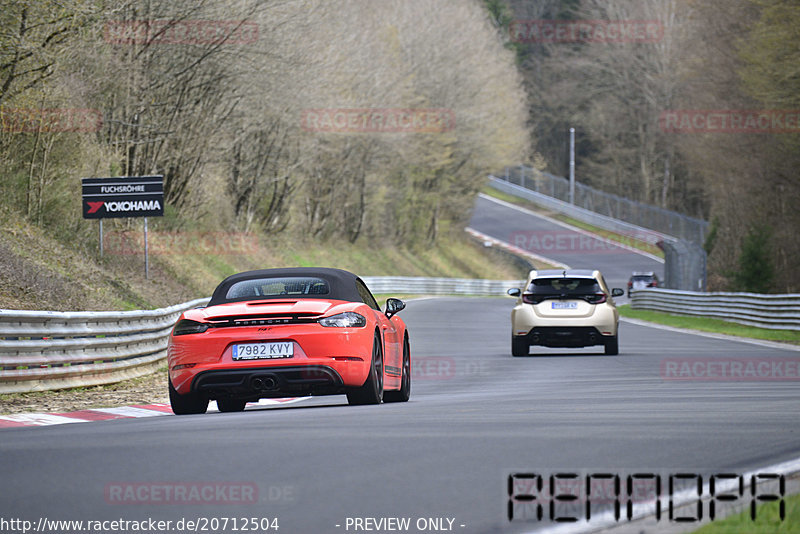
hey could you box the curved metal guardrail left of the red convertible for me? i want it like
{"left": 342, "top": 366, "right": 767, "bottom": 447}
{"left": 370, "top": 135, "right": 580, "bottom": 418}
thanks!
{"left": 0, "top": 298, "right": 208, "bottom": 393}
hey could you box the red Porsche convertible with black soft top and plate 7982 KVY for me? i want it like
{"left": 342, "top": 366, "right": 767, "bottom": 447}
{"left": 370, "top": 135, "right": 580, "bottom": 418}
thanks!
{"left": 167, "top": 268, "right": 411, "bottom": 414}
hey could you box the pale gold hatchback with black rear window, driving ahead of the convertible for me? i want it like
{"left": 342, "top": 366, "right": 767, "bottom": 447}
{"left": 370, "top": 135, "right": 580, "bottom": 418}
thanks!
{"left": 508, "top": 269, "right": 625, "bottom": 356}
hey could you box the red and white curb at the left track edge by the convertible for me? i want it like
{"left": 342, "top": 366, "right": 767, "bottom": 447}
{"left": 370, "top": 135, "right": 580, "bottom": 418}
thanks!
{"left": 0, "top": 397, "right": 309, "bottom": 428}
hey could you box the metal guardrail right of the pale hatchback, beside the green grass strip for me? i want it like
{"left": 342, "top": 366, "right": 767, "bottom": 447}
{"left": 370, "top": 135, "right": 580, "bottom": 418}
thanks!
{"left": 631, "top": 289, "right": 800, "bottom": 330}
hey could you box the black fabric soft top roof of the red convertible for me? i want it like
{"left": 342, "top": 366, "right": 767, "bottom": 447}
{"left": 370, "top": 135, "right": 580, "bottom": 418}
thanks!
{"left": 208, "top": 267, "right": 363, "bottom": 306}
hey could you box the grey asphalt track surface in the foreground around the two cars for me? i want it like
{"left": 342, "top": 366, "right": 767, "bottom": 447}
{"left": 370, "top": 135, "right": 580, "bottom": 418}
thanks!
{"left": 0, "top": 297, "right": 800, "bottom": 533}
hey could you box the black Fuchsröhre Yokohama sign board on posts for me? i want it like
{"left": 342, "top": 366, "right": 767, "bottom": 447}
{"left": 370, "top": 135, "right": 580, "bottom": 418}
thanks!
{"left": 81, "top": 176, "right": 164, "bottom": 219}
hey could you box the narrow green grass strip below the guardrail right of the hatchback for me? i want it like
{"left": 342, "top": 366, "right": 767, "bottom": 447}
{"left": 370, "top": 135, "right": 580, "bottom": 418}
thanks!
{"left": 617, "top": 304, "right": 800, "bottom": 344}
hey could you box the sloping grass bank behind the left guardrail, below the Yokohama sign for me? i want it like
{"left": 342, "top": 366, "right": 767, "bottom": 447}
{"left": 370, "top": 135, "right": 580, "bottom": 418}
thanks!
{"left": 0, "top": 209, "right": 527, "bottom": 311}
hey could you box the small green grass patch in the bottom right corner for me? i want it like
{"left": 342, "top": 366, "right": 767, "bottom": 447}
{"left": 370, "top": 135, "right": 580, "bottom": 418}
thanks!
{"left": 695, "top": 495, "right": 800, "bottom": 534}
